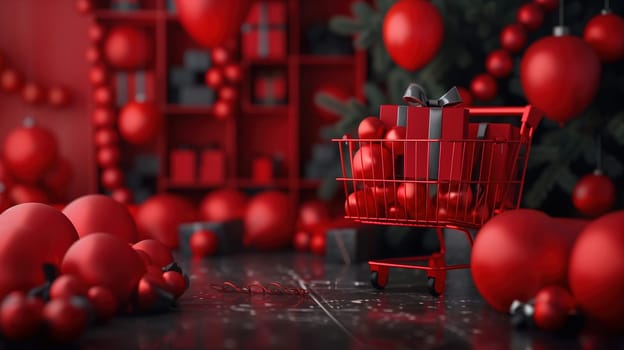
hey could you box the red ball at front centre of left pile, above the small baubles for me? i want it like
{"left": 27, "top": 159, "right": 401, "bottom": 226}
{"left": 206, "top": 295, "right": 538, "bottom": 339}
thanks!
{"left": 61, "top": 234, "right": 145, "bottom": 304}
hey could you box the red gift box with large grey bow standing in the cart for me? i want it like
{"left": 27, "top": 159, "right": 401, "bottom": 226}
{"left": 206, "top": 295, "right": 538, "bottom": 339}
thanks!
{"left": 379, "top": 84, "right": 471, "bottom": 182}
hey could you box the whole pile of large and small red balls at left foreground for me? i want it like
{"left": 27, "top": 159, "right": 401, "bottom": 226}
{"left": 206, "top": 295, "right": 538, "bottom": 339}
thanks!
{"left": 0, "top": 195, "right": 189, "bottom": 342}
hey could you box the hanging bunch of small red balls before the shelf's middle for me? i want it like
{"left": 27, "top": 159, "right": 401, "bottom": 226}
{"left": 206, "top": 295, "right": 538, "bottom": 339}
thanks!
{"left": 204, "top": 47, "right": 243, "bottom": 120}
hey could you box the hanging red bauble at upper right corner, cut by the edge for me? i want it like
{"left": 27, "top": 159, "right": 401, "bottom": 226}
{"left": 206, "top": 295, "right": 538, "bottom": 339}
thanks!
{"left": 583, "top": 13, "right": 624, "bottom": 62}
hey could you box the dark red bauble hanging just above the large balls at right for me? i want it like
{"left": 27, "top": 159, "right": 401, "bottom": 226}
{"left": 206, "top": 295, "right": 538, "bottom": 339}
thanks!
{"left": 572, "top": 174, "right": 616, "bottom": 216}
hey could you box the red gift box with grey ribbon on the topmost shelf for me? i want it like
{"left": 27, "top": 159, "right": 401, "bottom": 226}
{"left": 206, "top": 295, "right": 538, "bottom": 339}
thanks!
{"left": 242, "top": 1, "right": 286, "bottom": 58}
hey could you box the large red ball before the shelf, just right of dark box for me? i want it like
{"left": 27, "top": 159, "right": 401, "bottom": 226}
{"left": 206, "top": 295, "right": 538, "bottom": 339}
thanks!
{"left": 244, "top": 191, "right": 295, "bottom": 250}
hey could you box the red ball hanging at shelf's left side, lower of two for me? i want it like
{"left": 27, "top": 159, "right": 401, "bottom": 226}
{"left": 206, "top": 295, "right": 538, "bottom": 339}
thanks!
{"left": 118, "top": 101, "right": 163, "bottom": 145}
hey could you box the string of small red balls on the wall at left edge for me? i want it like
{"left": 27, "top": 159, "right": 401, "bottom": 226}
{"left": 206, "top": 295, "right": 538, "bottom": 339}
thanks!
{"left": 0, "top": 53, "right": 71, "bottom": 108}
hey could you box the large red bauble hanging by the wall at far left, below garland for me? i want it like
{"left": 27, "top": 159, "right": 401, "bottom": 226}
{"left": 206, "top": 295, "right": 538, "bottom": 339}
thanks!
{"left": 2, "top": 125, "right": 58, "bottom": 183}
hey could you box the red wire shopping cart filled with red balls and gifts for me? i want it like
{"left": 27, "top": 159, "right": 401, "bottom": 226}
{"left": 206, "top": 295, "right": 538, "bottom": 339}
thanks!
{"left": 333, "top": 105, "right": 542, "bottom": 296}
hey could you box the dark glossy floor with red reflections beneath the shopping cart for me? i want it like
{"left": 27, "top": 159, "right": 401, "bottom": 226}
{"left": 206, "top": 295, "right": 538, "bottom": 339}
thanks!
{"left": 64, "top": 253, "right": 624, "bottom": 350}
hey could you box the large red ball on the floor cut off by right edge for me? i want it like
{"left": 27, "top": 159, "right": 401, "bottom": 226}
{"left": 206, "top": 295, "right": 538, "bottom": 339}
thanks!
{"left": 570, "top": 211, "right": 624, "bottom": 330}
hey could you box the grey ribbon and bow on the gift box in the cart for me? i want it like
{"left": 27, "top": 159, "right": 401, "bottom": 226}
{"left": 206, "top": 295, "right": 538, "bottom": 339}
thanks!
{"left": 397, "top": 83, "right": 462, "bottom": 179}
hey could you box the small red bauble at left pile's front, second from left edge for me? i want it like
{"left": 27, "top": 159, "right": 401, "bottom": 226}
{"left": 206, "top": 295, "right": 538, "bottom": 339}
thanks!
{"left": 43, "top": 299, "right": 88, "bottom": 343}
